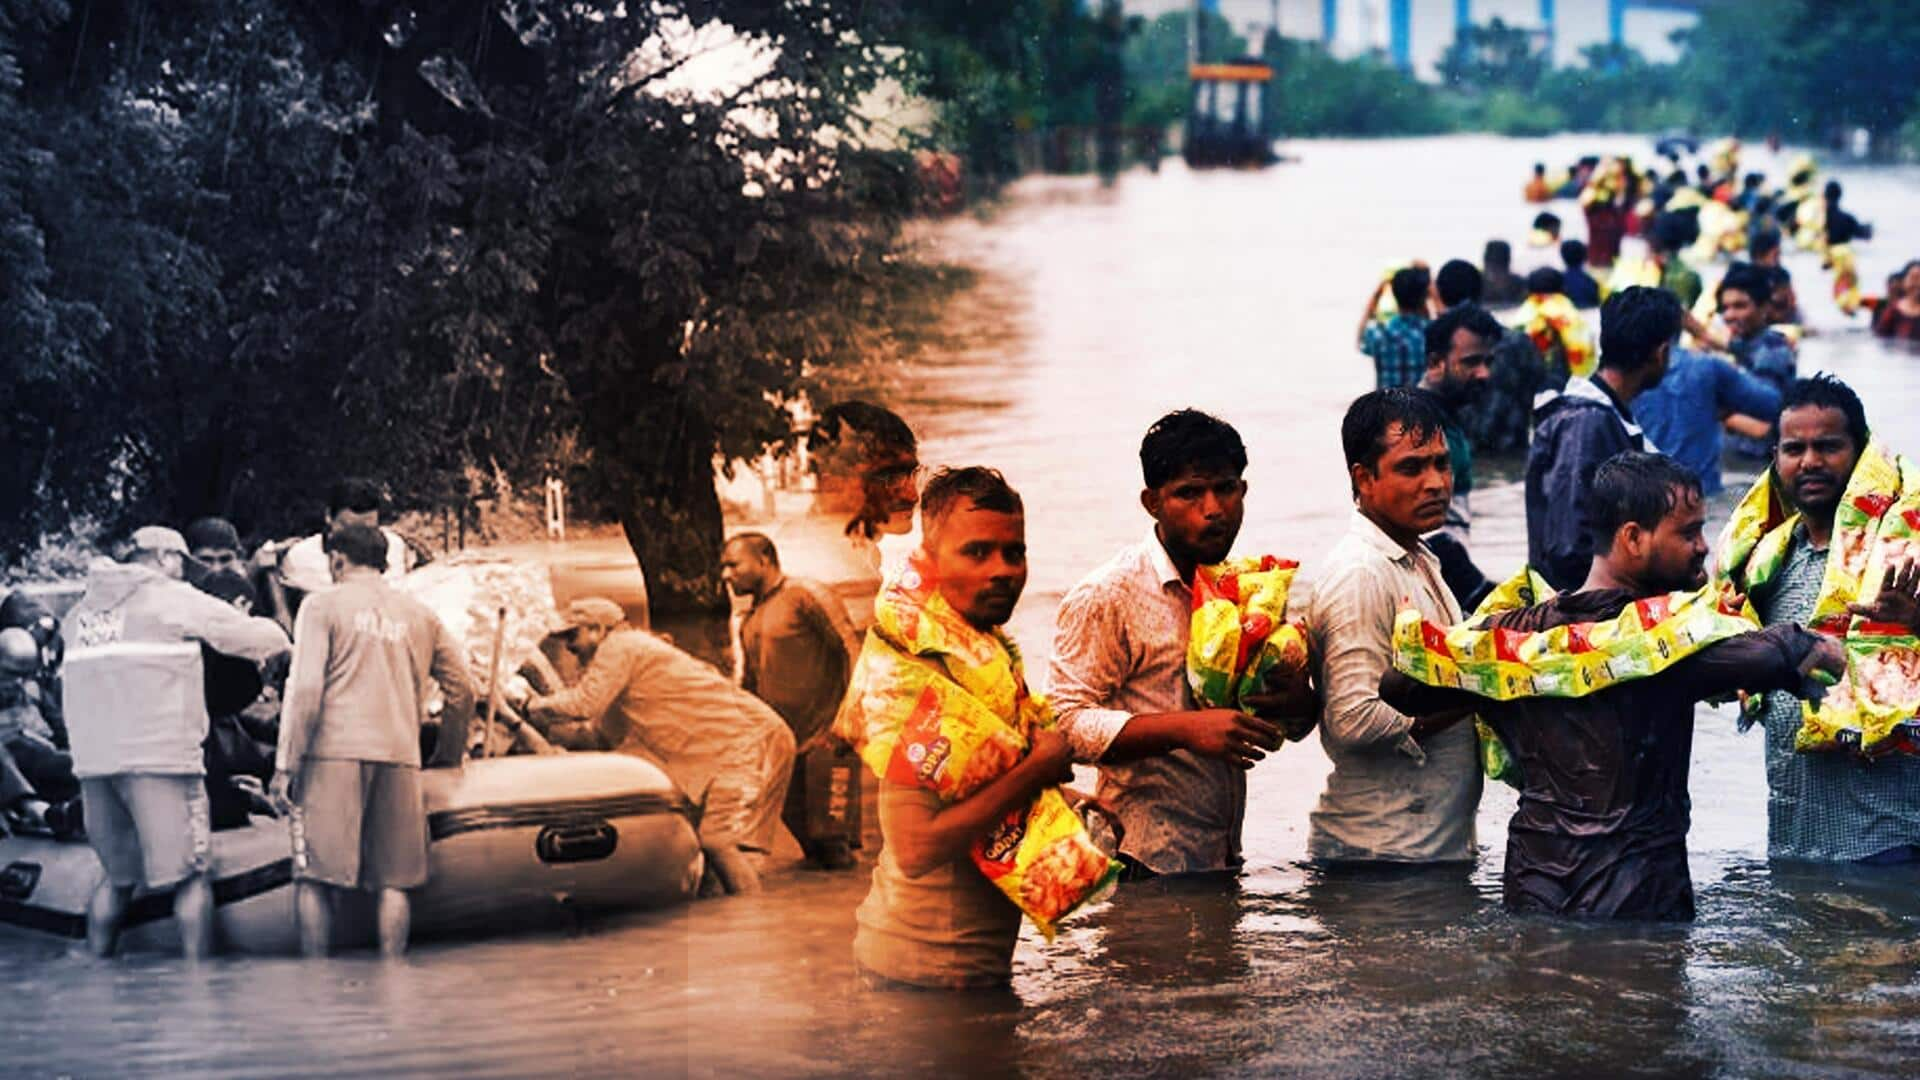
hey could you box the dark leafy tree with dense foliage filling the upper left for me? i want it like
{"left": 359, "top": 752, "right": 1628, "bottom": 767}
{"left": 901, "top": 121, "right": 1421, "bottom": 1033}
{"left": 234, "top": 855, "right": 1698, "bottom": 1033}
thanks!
{"left": 0, "top": 0, "right": 925, "bottom": 607}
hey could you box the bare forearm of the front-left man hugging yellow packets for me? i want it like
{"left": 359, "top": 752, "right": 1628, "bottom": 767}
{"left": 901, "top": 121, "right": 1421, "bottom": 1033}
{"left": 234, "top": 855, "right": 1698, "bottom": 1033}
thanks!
{"left": 879, "top": 730, "right": 1073, "bottom": 878}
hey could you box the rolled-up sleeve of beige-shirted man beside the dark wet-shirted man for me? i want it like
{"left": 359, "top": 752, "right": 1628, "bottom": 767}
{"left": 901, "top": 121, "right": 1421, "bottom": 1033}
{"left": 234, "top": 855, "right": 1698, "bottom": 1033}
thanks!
{"left": 1313, "top": 567, "right": 1427, "bottom": 761}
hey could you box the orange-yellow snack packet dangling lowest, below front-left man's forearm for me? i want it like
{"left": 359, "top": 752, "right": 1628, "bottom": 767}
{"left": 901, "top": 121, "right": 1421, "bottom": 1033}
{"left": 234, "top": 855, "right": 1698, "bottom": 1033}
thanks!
{"left": 973, "top": 788, "right": 1119, "bottom": 940}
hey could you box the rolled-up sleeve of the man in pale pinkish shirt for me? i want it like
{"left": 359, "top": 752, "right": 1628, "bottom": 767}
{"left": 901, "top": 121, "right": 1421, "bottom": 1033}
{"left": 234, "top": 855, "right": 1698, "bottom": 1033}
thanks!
{"left": 1048, "top": 586, "right": 1133, "bottom": 765}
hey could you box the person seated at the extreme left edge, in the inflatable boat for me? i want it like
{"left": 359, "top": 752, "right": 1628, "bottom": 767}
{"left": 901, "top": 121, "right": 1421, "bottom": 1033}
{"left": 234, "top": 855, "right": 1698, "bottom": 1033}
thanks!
{"left": 0, "top": 626, "right": 81, "bottom": 836}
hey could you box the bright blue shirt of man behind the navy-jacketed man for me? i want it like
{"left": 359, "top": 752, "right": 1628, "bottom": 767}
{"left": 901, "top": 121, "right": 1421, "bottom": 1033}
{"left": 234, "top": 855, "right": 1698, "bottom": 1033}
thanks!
{"left": 1634, "top": 348, "right": 1780, "bottom": 496}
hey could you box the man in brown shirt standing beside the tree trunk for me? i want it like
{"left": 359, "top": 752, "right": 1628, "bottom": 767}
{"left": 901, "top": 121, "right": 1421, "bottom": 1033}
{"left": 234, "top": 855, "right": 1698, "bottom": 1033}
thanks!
{"left": 720, "top": 532, "right": 860, "bottom": 869}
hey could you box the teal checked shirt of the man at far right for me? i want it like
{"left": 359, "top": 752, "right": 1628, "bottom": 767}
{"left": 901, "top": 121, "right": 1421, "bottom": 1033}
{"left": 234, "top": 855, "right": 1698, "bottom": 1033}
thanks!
{"left": 1753, "top": 532, "right": 1920, "bottom": 863}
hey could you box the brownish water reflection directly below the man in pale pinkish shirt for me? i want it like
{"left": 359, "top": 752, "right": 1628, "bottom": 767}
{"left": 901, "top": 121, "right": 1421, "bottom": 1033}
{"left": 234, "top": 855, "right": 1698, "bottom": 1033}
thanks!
{"left": 1096, "top": 872, "right": 1250, "bottom": 988}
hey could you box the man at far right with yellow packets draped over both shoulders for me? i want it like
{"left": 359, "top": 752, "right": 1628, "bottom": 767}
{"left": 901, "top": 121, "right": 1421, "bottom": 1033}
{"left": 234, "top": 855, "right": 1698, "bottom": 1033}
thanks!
{"left": 1718, "top": 375, "right": 1920, "bottom": 863}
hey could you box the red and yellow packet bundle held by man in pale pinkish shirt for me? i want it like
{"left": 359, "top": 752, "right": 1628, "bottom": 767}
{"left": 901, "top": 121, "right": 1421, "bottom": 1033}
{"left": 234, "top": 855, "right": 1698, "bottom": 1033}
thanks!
{"left": 1187, "top": 555, "right": 1308, "bottom": 713}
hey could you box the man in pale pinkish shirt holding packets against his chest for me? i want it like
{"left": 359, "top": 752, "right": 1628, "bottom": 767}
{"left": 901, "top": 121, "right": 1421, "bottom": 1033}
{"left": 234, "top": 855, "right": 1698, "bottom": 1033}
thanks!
{"left": 1052, "top": 409, "right": 1305, "bottom": 880}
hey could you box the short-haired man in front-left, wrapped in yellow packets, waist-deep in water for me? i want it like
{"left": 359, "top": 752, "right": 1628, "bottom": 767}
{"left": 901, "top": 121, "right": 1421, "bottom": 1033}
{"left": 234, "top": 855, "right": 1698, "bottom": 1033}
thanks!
{"left": 833, "top": 467, "right": 1119, "bottom": 990}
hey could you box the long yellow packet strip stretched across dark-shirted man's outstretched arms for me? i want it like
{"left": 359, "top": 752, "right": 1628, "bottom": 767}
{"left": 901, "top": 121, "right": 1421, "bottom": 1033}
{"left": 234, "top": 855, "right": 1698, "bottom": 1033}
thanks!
{"left": 1394, "top": 572, "right": 1757, "bottom": 701}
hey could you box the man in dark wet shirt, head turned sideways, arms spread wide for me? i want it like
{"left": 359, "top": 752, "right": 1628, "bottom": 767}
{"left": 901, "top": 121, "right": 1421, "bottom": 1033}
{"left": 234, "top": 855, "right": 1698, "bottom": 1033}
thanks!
{"left": 1380, "top": 452, "right": 1843, "bottom": 919}
